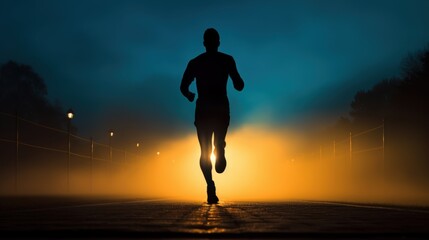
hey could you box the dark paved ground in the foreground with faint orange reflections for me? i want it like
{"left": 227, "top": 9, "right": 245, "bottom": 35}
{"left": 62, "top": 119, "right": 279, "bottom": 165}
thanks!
{"left": 0, "top": 197, "right": 429, "bottom": 239}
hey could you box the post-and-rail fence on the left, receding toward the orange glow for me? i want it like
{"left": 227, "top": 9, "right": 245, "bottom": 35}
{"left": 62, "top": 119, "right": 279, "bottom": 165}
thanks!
{"left": 0, "top": 112, "right": 139, "bottom": 193}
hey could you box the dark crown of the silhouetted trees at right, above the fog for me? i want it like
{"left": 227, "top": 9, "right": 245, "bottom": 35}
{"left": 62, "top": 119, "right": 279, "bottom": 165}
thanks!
{"left": 350, "top": 47, "right": 429, "bottom": 128}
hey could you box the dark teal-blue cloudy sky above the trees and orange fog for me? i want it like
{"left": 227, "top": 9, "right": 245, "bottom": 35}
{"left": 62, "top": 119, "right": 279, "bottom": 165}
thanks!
{"left": 0, "top": 0, "right": 429, "bottom": 145}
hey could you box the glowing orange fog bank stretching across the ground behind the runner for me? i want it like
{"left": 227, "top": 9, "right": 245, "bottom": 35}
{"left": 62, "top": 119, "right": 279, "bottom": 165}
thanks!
{"left": 1, "top": 125, "right": 429, "bottom": 205}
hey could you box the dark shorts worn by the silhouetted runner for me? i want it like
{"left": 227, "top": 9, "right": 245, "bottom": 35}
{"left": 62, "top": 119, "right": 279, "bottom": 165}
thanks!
{"left": 194, "top": 99, "right": 230, "bottom": 130}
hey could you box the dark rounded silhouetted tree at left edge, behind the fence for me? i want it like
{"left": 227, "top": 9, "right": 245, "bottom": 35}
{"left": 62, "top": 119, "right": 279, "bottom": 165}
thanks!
{"left": 0, "top": 61, "right": 77, "bottom": 187}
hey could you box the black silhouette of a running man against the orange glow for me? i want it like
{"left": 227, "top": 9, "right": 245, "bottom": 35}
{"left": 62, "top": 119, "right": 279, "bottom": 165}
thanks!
{"left": 180, "top": 28, "right": 244, "bottom": 204}
